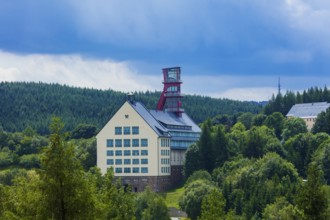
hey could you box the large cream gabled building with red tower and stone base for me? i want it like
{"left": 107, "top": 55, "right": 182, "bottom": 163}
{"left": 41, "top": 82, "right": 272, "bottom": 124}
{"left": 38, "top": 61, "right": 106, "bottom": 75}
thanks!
{"left": 96, "top": 67, "right": 201, "bottom": 191}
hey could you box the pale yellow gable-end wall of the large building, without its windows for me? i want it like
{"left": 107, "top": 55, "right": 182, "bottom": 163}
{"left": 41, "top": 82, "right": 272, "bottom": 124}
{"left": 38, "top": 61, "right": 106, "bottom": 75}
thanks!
{"left": 97, "top": 102, "right": 161, "bottom": 176}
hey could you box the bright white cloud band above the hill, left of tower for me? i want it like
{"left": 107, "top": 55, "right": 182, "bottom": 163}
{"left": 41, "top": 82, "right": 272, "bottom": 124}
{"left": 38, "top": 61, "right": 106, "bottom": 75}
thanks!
{"left": 0, "top": 52, "right": 161, "bottom": 92}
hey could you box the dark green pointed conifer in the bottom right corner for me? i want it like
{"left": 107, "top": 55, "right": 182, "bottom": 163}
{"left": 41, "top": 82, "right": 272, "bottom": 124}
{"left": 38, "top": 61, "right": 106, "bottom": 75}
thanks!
{"left": 297, "top": 163, "right": 329, "bottom": 219}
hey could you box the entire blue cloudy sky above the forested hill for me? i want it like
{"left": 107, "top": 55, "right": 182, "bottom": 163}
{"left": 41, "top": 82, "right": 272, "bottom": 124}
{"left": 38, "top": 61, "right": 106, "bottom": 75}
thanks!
{"left": 0, "top": 0, "right": 330, "bottom": 101}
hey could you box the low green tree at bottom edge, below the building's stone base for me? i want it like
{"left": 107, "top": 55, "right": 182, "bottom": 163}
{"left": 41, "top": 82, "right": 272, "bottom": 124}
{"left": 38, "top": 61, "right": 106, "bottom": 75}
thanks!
{"left": 136, "top": 187, "right": 170, "bottom": 220}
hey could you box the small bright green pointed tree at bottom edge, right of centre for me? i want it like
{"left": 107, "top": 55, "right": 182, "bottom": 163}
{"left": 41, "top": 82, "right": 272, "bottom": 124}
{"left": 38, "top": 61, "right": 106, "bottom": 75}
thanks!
{"left": 198, "top": 188, "right": 226, "bottom": 220}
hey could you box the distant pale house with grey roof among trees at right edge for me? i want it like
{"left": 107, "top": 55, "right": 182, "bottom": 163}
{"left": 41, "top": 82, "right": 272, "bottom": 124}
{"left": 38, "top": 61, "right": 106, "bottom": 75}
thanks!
{"left": 286, "top": 102, "right": 330, "bottom": 130}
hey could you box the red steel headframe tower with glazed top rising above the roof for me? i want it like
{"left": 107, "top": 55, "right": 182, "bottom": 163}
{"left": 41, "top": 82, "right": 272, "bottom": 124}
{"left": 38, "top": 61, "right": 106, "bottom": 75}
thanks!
{"left": 157, "top": 67, "right": 183, "bottom": 116}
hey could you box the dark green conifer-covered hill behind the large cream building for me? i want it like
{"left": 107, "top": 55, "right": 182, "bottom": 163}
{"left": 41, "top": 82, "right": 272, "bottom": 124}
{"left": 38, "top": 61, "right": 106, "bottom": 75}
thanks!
{"left": 0, "top": 82, "right": 262, "bottom": 134}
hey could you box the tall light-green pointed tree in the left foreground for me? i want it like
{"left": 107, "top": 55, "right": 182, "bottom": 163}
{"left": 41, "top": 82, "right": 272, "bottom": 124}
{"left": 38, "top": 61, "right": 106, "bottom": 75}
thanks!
{"left": 40, "top": 118, "right": 95, "bottom": 220}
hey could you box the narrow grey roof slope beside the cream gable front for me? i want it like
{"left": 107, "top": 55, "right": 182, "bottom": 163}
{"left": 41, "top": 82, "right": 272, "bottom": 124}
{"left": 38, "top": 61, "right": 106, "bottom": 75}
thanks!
{"left": 128, "top": 102, "right": 169, "bottom": 136}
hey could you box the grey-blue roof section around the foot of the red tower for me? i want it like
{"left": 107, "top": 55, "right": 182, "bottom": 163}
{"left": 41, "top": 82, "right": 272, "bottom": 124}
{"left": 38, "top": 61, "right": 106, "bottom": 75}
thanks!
{"left": 150, "top": 110, "right": 201, "bottom": 132}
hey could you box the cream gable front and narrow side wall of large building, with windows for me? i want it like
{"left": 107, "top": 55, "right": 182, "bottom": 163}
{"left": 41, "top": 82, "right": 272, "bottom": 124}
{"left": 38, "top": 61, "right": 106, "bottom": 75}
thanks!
{"left": 96, "top": 102, "right": 171, "bottom": 177}
